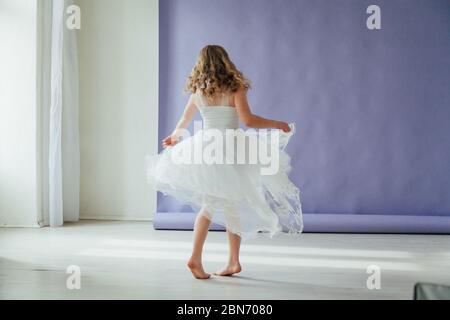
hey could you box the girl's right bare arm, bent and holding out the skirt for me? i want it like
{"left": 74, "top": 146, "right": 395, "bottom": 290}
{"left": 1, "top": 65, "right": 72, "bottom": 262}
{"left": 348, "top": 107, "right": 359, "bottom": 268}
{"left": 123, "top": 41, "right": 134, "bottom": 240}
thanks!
{"left": 234, "top": 89, "right": 291, "bottom": 132}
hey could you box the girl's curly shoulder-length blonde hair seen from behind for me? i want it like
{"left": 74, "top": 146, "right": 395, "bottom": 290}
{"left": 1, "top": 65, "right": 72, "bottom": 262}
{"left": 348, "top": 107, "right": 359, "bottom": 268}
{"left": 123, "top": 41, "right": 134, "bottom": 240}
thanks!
{"left": 186, "top": 45, "right": 251, "bottom": 98}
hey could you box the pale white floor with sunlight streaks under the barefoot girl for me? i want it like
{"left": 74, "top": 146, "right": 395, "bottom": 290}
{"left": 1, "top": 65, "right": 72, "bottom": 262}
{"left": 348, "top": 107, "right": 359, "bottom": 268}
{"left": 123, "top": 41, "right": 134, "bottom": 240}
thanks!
{"left": 0, "top": 221, "right": 450, "bottom": 299}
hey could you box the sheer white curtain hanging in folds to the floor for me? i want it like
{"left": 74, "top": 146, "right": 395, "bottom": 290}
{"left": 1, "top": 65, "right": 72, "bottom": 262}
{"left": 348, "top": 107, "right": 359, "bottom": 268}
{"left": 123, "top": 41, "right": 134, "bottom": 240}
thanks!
{"left": 40, "top": 0, "right": 80, "bottom": 227}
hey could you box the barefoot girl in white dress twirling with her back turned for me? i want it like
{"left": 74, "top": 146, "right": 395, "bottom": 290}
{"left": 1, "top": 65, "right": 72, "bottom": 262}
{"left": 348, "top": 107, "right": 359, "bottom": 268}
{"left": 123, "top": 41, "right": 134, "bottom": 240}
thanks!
{"left": 148, "top": 45, "right": 303, "bottom": 279}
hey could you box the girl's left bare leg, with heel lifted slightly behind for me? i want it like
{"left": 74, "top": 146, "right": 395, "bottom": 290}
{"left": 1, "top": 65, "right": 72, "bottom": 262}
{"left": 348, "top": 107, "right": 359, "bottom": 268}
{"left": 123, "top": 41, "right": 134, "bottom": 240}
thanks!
{"left": 188, "top": 209, "right": 211, "bottom": 279}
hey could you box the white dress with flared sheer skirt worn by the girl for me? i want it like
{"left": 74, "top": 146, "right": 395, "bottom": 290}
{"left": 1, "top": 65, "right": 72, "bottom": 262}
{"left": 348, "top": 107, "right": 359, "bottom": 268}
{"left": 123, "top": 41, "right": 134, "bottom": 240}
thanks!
{"left": 147, "top": 94, "right": 303, "bottom": 240}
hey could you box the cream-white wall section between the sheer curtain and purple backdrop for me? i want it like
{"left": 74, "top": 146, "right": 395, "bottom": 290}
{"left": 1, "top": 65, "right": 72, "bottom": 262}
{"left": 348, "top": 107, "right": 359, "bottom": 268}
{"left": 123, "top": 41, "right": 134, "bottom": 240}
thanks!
{"left": 78, "top": 0, "right": 158, "bottom": 220}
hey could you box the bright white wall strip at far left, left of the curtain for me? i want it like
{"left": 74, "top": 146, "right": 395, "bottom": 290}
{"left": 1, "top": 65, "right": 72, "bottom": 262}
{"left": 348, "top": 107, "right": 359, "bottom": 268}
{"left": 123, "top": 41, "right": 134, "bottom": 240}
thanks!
{"left": 0, "top": 0, "right": 39, "bottom": 227}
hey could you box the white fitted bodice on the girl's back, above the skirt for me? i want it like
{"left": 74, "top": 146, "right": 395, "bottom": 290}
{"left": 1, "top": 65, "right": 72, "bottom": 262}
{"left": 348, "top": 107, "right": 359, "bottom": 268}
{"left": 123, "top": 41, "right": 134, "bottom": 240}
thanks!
{"left": 197, "top": 94, "right": 239, "bottom": 130}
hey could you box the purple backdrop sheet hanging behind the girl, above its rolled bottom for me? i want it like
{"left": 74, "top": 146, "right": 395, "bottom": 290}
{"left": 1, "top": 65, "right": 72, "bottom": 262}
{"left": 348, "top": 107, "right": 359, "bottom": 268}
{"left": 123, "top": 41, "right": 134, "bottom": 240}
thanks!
{"left": 158, "top": 0, "right": 450, "bottom": 230}
